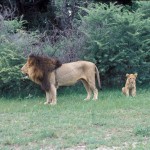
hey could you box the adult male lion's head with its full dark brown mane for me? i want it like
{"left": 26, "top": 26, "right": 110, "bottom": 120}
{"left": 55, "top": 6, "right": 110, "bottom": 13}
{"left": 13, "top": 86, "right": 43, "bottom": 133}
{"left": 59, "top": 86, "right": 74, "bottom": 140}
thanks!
{"left": 21, "top": 54, "right": 62, "bottom": 91}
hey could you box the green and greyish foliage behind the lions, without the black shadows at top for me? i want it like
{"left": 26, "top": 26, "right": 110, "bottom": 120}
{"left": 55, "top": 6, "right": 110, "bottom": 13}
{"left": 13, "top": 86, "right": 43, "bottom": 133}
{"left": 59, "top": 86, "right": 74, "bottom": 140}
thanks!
{"left": 0, "top": 0, "right": 150, "bottom": 95}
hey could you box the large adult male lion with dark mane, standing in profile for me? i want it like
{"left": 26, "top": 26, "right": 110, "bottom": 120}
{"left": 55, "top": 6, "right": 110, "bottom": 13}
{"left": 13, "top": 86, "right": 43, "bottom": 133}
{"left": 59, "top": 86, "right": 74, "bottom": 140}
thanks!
{"left": 21, "top": 54, "right": 101, "bottom": 105}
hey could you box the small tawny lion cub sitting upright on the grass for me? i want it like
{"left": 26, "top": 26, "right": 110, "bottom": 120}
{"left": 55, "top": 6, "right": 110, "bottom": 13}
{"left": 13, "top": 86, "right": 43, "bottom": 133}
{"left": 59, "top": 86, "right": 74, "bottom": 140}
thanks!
{"left": 122, "top": 73, "right": 137, "bottom": 97}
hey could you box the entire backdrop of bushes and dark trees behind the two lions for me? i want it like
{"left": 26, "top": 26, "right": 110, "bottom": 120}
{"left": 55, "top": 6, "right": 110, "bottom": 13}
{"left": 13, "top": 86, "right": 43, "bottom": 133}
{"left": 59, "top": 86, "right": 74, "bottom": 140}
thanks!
{"left": 0, "top": 0, "right": 150, "bottom": 97}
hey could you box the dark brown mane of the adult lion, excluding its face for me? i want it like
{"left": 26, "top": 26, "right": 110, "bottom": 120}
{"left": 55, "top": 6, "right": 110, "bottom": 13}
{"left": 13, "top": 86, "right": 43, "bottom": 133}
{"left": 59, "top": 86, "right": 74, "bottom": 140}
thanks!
{"left": 29, "top": 53, "right": 62, "bottom": 91}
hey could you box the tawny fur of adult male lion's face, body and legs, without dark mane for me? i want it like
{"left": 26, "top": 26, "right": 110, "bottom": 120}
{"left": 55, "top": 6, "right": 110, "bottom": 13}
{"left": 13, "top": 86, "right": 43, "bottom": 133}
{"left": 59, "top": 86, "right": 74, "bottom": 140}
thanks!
{"left": 21, "top": 56, "right": 101, "bottom": 105}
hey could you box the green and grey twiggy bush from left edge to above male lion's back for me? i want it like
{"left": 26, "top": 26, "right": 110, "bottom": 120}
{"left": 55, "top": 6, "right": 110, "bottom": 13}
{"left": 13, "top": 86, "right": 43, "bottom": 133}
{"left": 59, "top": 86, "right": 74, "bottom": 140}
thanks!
{"left": 0, "top": 12, "right": 84, "bottom": 95}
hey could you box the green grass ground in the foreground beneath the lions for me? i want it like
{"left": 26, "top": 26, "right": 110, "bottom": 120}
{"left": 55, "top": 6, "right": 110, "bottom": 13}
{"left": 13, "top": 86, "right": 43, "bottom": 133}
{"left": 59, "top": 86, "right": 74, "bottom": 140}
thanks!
{"left": 0, "top": 89, "right": 150, "bottom": 150}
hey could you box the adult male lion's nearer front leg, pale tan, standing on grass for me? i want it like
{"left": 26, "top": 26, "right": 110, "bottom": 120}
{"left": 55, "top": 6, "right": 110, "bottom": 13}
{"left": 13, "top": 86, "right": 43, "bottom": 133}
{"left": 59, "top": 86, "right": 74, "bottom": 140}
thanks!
{"left": 50, "top": 84, "right": 57, "bottom": 105}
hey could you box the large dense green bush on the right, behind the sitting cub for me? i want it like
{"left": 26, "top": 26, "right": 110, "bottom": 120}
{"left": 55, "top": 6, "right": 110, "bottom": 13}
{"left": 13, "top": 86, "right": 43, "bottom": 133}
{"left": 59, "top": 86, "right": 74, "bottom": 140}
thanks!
{"left": 80, "top": 2, "right": 150, "bottom": 84}
